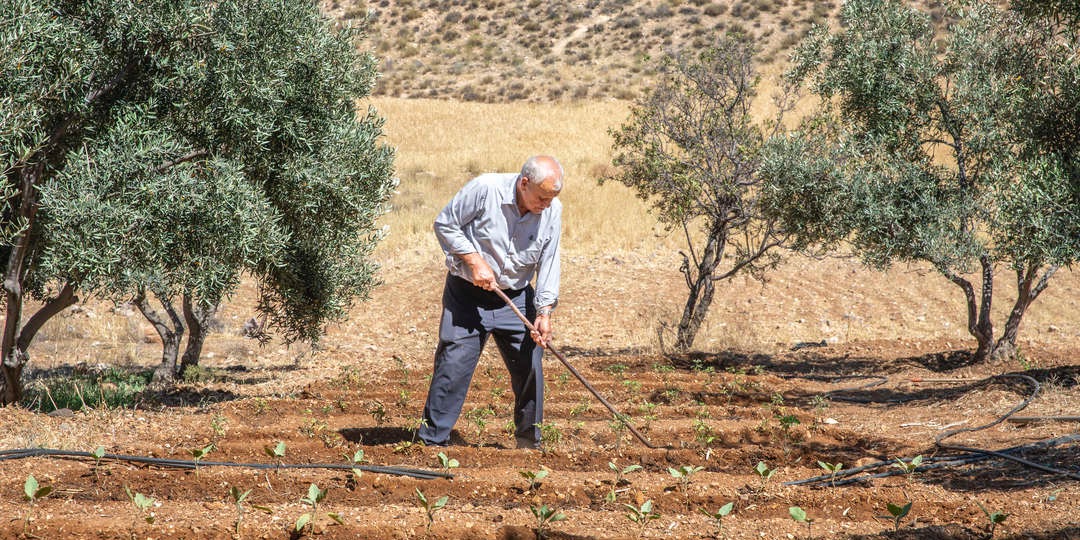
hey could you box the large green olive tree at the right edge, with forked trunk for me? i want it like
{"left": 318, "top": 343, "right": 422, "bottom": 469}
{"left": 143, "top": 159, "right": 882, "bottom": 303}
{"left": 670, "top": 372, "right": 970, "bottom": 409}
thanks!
{"left": 764, "top": 0, "right": 1080, "bottom": 361}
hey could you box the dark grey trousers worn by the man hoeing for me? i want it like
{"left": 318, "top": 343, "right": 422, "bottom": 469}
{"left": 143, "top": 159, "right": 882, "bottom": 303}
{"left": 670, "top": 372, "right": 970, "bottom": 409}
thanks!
{"left": 418, "top": 274, "right": 543, "bottom": 445}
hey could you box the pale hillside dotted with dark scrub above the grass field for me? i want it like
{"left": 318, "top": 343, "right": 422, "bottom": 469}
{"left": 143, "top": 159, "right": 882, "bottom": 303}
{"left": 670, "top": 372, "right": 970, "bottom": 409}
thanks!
{"left": 323, "top": 0, "right": 855, "bottom": 103}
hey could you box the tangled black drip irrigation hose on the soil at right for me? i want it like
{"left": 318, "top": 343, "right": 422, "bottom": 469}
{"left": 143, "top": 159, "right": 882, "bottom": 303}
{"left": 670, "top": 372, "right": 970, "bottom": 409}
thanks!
{"left": 783, "top": 374, "right": 1080, "bottom": 487}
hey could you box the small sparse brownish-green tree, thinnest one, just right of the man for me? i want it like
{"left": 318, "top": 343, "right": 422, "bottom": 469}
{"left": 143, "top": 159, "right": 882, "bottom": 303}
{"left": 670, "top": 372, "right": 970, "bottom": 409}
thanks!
{"left": 600, "top": 36, "right": 787, "bottom": 351}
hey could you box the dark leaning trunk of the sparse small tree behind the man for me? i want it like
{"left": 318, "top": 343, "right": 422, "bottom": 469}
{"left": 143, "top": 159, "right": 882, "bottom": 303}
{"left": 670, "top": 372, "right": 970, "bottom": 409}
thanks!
{"left": 675, "top": 226, "right": 726, "bottom": 352}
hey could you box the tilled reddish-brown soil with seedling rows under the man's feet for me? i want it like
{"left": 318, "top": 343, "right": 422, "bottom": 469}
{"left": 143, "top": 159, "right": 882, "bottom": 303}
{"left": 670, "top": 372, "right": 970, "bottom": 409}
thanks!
{"left": 0, "top": 255, "right": 1080, "bottom": 540}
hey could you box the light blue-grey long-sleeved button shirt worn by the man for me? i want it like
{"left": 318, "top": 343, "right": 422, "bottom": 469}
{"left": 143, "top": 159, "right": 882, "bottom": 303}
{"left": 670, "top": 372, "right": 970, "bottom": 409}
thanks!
{"left": 435, "top": 173, "right": 563, "bottom": 308}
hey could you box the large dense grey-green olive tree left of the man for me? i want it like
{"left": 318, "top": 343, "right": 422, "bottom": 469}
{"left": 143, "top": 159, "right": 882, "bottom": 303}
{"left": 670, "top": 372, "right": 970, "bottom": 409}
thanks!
{"left": 0, "top": 0, "right": 393, "bottom": 403}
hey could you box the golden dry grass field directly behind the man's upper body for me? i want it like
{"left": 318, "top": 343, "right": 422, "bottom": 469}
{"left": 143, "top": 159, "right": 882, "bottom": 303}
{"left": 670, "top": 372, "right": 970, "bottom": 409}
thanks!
{"left": 373, "top": 98, "right": 673, "bottom": 256}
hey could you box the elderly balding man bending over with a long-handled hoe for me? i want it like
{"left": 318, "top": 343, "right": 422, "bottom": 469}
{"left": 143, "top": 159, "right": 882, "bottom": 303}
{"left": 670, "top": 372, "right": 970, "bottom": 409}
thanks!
{"left": 419, "top": 156, "right": 563, "bottom": 448}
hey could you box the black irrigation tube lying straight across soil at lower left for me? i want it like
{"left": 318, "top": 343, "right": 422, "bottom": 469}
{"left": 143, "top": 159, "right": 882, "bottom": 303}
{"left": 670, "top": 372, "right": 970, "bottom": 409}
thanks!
{"left": 0, "top": 448, "right": 454, "bottom": 480}
